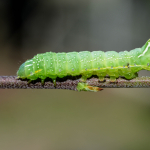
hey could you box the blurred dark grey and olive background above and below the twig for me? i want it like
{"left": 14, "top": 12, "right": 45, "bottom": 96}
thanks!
{"left": 0, "top": 0, "right": 150, "bottom": 150}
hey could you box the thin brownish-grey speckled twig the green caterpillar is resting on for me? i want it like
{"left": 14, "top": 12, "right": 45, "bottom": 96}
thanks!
{"left": 0, "top": 76, "right": 150, "bottom": 90}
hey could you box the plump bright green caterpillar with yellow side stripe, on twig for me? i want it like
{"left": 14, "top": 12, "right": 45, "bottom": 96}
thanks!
{"left": 17, "top": 39, "right": 150, "bottom": 91}
